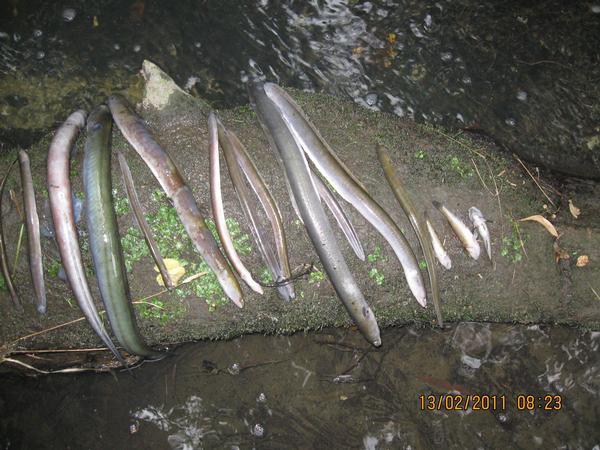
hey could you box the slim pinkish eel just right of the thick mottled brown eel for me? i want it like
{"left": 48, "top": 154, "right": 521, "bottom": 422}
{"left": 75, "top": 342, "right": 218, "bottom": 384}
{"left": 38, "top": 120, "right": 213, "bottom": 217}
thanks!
{"left": 208, "top": 111, "right": 264, "bottom": 295}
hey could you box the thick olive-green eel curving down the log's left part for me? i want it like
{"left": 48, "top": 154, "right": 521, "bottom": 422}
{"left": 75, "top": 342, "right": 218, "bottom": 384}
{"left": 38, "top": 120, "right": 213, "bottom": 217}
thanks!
{"left": 83, "top": 105, "right": 163, "bottom": 358}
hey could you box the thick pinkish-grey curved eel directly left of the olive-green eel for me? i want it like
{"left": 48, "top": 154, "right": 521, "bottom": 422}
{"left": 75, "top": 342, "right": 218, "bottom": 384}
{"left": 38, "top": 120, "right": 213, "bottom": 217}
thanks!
{"left": 47, "top": 110, "right": 126, "bottom": 365}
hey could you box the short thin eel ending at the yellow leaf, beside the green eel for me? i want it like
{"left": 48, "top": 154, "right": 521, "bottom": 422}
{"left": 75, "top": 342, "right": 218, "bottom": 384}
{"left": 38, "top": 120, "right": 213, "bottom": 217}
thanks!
{"left": 117, "top": 152, "right": 175, "bottom": 289}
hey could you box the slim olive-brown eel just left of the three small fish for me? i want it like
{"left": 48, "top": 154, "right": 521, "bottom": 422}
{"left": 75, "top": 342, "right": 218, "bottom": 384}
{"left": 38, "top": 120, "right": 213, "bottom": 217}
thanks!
{"left": 377, "top": 144, "right": 444, "bottom": 327}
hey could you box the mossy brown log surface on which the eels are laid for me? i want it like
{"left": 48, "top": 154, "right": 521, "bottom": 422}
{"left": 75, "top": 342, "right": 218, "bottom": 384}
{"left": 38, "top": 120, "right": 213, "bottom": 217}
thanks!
{"left": 0, "top": 61, "right": 600, "bottom": 360}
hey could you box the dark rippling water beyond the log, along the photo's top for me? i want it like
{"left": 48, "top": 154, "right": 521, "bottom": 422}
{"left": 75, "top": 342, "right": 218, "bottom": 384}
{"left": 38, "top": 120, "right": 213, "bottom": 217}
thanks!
{"left": 0, "top": 0, "right": 600, "bottom": 178}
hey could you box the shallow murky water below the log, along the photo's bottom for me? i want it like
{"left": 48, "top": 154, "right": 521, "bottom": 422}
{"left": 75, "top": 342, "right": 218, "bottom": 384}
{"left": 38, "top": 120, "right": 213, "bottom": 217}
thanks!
{"left": 0, "top": 323, "right": 600, "bottom": 449}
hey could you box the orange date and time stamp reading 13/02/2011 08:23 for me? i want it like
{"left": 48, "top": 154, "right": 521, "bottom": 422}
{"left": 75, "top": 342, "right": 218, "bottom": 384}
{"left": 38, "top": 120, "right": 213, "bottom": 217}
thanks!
{"left": 419, "top": 394, "right": 563, "bottom": 411}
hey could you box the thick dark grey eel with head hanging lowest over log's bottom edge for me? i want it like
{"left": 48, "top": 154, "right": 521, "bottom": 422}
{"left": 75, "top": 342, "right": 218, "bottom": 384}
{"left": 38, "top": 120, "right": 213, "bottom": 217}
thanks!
{"left": 250, "top": 84, "right": 381, "bottom": 346}
